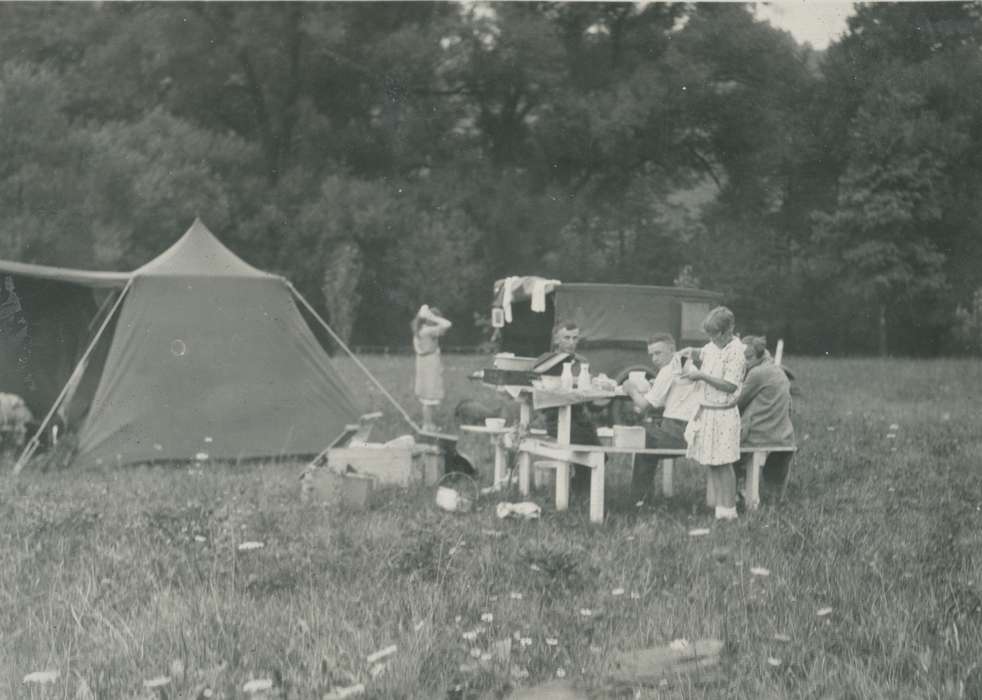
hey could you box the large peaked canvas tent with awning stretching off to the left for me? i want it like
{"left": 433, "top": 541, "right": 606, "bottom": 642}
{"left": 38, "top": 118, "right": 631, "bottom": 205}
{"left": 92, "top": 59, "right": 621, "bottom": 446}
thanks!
{"left": 0, "top": 220, "right": 361, "bottom": 465}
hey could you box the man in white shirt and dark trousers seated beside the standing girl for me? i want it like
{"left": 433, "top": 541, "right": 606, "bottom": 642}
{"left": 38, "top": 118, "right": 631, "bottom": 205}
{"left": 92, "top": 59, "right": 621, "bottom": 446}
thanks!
{"left": 624, "top": 333, "right": 702, "bottom": 500}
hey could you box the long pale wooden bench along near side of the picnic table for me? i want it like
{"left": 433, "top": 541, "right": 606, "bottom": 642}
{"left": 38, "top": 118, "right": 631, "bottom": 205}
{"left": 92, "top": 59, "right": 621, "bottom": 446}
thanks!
{"left": 518, "top": 438, "right": 796, "bottom": 523}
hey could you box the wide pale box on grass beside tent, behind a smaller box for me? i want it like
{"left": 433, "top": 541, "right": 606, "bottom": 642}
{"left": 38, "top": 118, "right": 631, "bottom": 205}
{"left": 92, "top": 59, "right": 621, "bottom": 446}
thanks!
{"left": 327, "top": 445, "right": 443, "bottom": 487}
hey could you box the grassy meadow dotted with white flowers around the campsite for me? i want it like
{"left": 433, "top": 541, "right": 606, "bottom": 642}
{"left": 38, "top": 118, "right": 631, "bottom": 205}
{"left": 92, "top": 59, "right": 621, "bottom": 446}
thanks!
{"left": 0, "top": 356, "right": 982, "bottom": 699}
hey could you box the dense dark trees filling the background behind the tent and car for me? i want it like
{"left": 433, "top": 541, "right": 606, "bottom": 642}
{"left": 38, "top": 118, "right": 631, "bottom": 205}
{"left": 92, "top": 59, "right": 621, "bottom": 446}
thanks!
{"left": 0, "top": 2, "right": 982, "bottom": 355}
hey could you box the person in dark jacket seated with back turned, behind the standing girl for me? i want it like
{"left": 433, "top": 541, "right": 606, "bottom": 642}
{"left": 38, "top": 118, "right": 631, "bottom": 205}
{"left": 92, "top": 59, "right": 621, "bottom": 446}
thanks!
{"left": 736, "top": 335, "right": 795, "bottom": 494}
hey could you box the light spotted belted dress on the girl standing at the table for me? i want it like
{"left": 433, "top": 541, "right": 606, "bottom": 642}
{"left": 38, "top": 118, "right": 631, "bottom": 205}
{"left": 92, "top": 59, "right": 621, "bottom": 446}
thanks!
{"left": 685, "top": 338, "right": 746, "bottom": 465}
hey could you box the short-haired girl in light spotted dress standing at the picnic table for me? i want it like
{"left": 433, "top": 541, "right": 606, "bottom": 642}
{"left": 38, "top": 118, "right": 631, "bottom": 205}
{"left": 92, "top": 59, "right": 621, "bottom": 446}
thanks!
{"left": 683, "top": 306, "right": 746, "bottom": 520}
